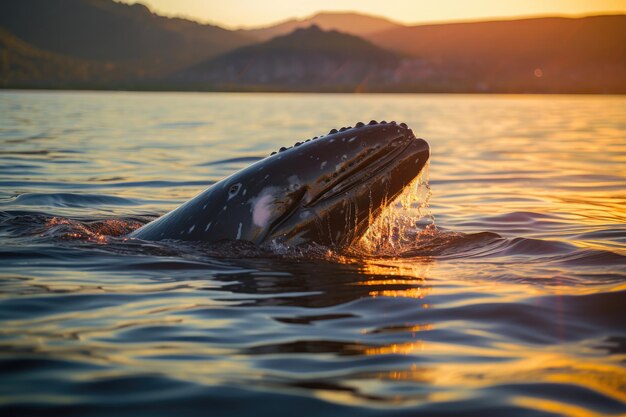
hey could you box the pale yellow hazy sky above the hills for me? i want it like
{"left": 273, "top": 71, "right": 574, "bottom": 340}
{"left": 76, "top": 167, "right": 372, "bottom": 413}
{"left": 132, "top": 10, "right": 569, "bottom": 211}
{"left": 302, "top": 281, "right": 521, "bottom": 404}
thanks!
{"left": 124, "top": 0, "right": 626, "bottom": 28}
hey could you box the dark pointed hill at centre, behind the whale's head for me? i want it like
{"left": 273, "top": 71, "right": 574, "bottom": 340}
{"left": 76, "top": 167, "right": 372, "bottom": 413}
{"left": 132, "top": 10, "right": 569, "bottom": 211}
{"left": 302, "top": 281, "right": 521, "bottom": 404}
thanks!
{"left": 174, "top": 26, "right": 400, "bottom": 91}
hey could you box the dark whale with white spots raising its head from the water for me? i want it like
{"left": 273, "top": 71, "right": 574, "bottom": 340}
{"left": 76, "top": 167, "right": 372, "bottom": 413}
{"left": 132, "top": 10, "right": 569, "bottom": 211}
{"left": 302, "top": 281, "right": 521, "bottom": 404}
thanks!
{"left": 129, "top": 120, "right": 430, "bottom": 248}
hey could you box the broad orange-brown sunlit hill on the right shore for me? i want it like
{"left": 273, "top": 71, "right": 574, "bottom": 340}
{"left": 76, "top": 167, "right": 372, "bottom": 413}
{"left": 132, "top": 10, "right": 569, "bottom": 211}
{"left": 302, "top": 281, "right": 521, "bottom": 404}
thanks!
{"left": 366, "top": 15, "right": 626, "bottom": 93}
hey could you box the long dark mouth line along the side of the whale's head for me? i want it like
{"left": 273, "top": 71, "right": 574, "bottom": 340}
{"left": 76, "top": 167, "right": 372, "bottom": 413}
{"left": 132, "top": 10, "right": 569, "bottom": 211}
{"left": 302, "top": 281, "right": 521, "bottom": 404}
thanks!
{"left": 303, "top": 136, "right": 415, "bottom": 207}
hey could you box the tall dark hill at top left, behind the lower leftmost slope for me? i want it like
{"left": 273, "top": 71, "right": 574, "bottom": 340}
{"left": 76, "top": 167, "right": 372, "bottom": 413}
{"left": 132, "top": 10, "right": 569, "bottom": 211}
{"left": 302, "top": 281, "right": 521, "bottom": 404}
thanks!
{"left": 0, "top": 0, "right": 253, "bottom": 76}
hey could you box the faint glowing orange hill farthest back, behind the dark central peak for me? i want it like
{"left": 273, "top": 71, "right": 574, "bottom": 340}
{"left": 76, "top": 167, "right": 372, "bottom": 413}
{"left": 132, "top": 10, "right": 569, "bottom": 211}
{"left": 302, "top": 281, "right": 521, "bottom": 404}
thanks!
{"left": 240, "top": 12, "right": 404, "bottom": 41}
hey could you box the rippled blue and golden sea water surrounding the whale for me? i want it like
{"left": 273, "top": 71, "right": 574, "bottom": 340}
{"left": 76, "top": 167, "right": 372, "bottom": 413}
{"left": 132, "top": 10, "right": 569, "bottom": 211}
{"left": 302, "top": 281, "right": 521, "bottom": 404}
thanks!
{"left": 0, "top": 91, "right": 626, "bottom": 417}
